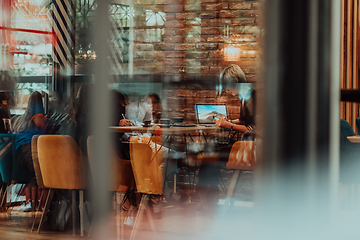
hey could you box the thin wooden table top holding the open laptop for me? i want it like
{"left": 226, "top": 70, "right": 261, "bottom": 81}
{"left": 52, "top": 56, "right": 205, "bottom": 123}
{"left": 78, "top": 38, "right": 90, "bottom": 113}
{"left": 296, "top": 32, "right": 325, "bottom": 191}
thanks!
{"left": 110, "top": 125, "right": 221, "bottom": 135}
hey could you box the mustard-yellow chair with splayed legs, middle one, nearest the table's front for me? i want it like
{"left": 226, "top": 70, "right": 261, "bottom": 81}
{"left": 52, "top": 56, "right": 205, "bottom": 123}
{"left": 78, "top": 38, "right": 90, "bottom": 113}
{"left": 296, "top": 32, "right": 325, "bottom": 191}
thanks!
{"left": 130, "top": 140, "right": 164, "bottom": 239}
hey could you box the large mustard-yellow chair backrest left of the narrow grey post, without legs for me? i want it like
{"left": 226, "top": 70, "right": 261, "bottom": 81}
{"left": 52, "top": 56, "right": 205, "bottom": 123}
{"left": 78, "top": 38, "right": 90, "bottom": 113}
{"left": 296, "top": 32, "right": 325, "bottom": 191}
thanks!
{"left": 37, "top": 135, "right": 86, "bottom": 189}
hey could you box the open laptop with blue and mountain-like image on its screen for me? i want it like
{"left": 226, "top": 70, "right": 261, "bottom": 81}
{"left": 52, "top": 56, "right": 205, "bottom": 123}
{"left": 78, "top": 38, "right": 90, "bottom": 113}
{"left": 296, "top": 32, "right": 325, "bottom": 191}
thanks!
{"left": 195, "top": 103, "right": 227, "bottom": 126}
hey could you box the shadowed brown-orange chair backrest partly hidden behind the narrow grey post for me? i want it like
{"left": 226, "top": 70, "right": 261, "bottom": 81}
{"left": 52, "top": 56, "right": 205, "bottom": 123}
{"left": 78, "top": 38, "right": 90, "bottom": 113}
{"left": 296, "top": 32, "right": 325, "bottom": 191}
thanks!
{"left": 87, "top": 136, "right": 134, "bottom": 192}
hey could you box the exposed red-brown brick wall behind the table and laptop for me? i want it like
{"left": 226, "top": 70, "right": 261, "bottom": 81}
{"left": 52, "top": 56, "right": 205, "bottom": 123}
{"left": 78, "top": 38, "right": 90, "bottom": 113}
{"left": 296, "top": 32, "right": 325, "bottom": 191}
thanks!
{"left": 134, "top": 0, "right": 260, "bottom": 124}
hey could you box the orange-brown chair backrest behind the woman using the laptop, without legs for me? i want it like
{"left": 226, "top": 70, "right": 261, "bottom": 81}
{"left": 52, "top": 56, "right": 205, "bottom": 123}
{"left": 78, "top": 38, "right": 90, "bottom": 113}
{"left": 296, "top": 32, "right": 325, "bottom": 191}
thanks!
{"left": 226, "top": 141, "right": 255, "bottom": 170}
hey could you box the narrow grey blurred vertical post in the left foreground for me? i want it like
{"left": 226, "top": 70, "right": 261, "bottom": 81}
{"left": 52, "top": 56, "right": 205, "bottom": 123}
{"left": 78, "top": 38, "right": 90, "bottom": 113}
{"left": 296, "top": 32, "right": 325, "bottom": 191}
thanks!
{"left": 89, "top": 0, "right": 112, "bottom": 239}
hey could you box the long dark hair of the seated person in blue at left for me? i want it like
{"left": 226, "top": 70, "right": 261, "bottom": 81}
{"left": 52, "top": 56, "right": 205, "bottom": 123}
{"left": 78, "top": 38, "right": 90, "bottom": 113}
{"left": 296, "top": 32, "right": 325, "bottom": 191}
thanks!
{"left": 14, "top": 91, "right": 44, "bottom": 132}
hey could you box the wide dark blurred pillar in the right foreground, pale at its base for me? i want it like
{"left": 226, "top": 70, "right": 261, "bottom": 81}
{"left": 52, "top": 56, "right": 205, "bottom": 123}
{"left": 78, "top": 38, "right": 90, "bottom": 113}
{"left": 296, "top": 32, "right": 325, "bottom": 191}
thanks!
{"left": 255, "top": 0, "right": 341, "bottom": 239}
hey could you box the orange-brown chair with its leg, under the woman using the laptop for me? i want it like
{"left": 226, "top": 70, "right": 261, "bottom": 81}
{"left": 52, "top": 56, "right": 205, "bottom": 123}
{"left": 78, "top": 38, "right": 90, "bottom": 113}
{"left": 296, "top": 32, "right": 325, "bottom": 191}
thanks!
{"left": 225, "top": 141, "right": 256, "bottom": 210}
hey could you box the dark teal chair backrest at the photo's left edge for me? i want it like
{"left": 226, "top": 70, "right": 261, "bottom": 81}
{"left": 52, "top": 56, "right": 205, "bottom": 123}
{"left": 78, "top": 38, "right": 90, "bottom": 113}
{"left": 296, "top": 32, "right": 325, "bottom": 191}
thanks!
{"left": 0, "top": 134, "right": 15, "bottom": 183}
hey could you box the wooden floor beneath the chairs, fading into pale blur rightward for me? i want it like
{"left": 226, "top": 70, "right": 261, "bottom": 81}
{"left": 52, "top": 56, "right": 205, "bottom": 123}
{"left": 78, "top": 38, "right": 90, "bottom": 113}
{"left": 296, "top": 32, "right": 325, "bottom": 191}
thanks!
{"left": 0, "top": 198, "right": 252, "bottom": 240}
